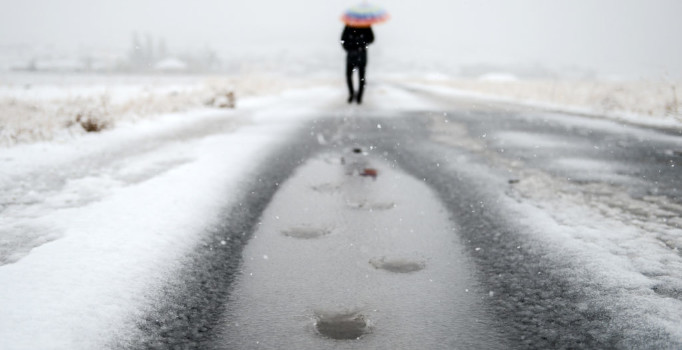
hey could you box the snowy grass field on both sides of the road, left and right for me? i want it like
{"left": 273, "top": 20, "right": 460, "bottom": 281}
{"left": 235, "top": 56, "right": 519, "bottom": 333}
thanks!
{"left": 0, "top": 72, "right": 682, "bottom": 146}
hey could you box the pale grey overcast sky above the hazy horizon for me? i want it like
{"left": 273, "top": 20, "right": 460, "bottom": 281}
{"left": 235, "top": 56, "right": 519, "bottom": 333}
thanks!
{"left": 0, "top": 0, "right": 682, "bottom": 78}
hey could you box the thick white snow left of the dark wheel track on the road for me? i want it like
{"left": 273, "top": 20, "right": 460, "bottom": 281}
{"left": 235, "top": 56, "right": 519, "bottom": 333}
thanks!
{"left": 0, "top": 89, "right": 338, "bottom": 349}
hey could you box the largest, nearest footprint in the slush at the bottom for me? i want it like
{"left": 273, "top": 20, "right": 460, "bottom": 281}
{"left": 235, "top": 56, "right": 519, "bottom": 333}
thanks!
{"left": 315, "top": 312, "right": 370, "bottom": 340}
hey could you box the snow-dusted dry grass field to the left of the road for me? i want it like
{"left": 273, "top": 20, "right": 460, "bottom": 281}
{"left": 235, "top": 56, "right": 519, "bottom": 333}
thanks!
{"left": 0, "top": 73, "right": 338, "bottom": 147}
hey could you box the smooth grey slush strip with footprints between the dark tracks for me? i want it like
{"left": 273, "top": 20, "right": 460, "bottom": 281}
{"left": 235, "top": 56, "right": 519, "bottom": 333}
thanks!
{"left": 216, "top": 152, "right": 504, "bottom": 349}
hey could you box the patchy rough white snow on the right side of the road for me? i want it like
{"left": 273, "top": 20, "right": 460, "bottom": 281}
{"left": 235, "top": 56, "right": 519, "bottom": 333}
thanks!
{"left": 428, "top": 112, "right": 682, "bottom": 345}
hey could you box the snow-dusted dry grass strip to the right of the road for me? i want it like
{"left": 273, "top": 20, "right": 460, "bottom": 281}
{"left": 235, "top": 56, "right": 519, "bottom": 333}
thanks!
{"left": 392, "top": 74, "right": 682, "bottom": 128}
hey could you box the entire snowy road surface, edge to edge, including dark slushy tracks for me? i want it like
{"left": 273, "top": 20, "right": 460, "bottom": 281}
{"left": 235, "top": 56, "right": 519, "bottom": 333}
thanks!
{"left": 0, "top": 85, "right": 682, "bottom": 349}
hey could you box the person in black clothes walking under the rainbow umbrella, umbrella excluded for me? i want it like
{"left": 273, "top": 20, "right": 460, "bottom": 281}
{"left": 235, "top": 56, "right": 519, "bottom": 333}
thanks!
{"left": 341, "top": 25, "right": 374, "bottom": 104}
